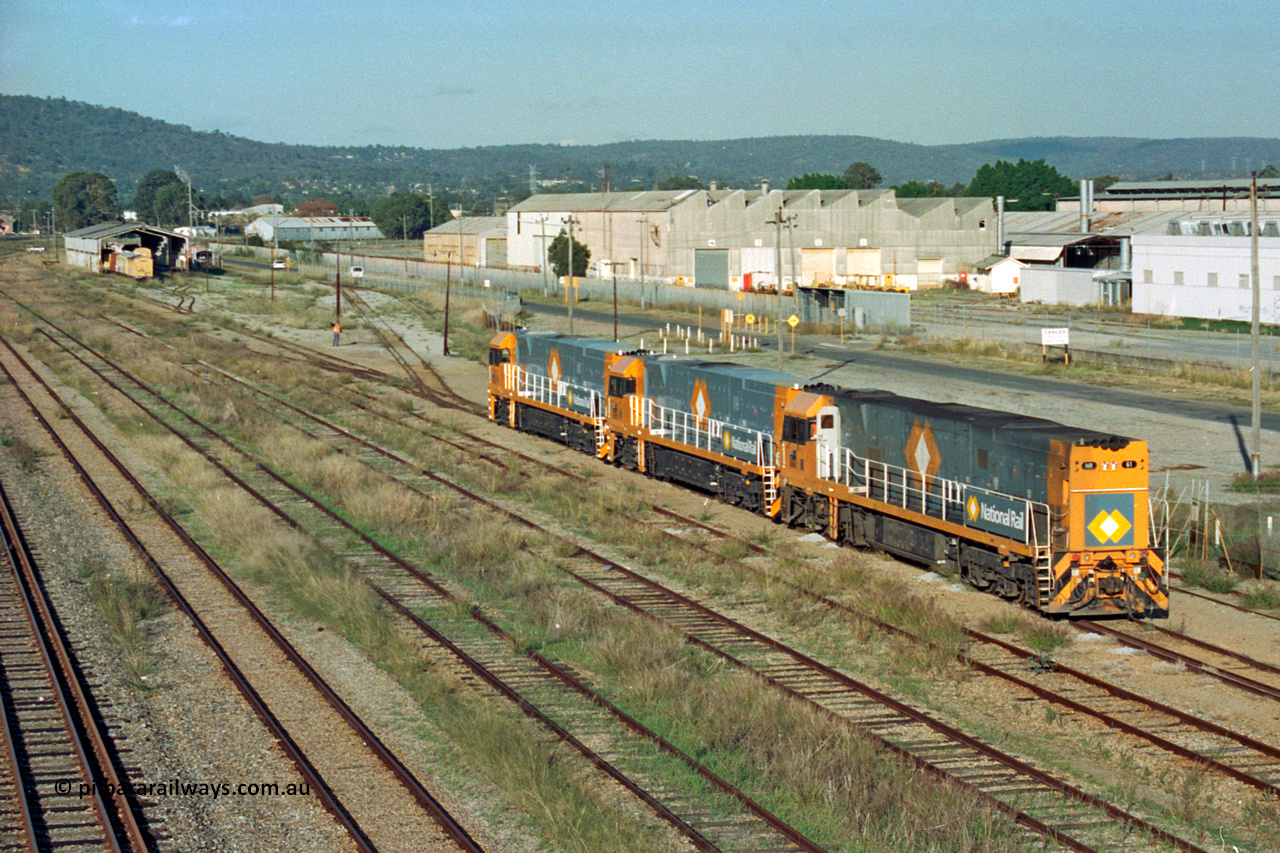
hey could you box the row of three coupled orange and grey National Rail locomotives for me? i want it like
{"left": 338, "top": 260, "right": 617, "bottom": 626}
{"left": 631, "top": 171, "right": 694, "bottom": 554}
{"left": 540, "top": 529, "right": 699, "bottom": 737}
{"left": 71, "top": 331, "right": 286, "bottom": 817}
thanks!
{"left": 489, "top": 330, "right": 1169, "bottom": 619}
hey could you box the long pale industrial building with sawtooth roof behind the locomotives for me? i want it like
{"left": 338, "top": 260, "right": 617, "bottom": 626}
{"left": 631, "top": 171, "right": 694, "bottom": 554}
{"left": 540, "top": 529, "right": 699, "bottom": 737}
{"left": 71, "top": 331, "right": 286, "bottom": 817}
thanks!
{"left": 507, "top": 184, "right": 996, "bottom": 289}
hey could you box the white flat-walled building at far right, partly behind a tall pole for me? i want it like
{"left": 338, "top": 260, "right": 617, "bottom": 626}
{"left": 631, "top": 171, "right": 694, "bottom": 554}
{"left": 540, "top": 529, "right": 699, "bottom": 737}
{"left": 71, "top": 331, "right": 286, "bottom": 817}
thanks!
{"left": 1130, "top": 228, "right": 1280, "bottom": 323}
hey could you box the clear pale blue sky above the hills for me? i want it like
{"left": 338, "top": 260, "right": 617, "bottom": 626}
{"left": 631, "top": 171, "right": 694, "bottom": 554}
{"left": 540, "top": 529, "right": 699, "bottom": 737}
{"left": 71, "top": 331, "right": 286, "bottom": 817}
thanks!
{"left": 0, "top": 0, "right": 1280, "bottom": 149}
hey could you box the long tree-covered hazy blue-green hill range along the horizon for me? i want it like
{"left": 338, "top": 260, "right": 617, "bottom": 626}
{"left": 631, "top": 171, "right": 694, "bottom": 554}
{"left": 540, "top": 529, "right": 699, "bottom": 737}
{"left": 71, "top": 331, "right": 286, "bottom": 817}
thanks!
{"left": 0, "top": 95, "right": 1280, "bottom": 206}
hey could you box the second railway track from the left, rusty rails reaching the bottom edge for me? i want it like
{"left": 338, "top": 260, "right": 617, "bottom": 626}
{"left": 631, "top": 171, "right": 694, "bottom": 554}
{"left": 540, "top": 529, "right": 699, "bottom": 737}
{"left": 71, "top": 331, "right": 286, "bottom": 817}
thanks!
{"left": 0, "top": 342, "right": 481, "bottom": 852}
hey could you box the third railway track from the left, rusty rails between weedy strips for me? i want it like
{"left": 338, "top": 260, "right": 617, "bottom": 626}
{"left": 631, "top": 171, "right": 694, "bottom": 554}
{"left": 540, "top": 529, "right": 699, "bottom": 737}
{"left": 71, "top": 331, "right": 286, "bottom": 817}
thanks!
{"left": 24, "top": 295, "right": 822, "bottom": 853}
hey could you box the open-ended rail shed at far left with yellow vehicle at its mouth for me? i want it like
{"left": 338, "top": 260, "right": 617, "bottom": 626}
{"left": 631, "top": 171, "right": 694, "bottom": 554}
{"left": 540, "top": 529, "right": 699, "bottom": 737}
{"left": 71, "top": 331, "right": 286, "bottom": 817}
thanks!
{"left": 63, "top": 222, "right": 188, "bottom": 278}
